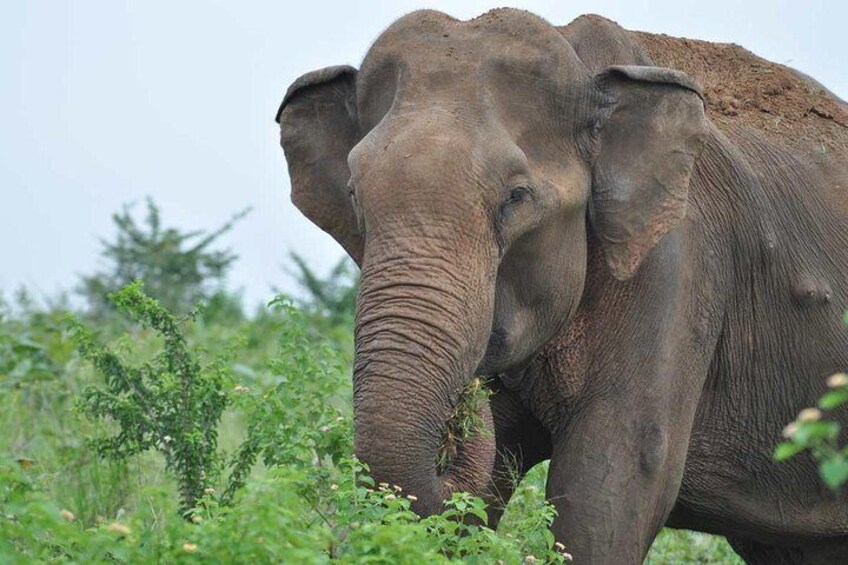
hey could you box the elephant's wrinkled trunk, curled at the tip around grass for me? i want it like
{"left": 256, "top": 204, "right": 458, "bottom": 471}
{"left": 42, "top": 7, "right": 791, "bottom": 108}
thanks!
{"left": 354, "top": 249, "right": 495, "bottom": 515}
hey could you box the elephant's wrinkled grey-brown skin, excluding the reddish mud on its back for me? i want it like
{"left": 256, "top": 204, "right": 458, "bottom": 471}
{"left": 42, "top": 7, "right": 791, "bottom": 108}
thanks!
{"left": 278, "top": 10, "right": 848, "bottom": 564}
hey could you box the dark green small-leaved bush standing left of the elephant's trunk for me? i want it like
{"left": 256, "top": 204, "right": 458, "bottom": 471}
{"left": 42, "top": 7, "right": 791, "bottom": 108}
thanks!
{"left": 68, "top": 281, "right": 235, "bottom": 513}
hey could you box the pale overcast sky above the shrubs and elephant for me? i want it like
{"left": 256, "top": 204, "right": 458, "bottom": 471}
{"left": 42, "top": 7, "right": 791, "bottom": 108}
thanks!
{"left": 0, "top": 0, "right": 848, "bottom": 303}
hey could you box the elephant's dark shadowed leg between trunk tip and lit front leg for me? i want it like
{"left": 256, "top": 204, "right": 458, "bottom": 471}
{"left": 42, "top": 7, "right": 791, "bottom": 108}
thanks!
{"left": 487, "top": 386, "right": 551, "bottom": 528}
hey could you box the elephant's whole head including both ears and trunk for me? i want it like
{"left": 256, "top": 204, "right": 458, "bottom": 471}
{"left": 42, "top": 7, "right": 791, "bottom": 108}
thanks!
{"left": 278, "top": 10, "right": 706, "bottom": 514}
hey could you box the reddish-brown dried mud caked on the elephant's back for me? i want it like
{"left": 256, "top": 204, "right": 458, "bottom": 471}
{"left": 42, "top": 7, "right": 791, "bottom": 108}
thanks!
{"left": 633, "top": 32, "right": 848, "bottom": 155}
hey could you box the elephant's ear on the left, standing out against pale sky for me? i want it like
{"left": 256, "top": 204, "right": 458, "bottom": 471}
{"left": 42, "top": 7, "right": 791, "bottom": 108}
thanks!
{"left": 277, "top": 66, "right": 364, "bottom": 265}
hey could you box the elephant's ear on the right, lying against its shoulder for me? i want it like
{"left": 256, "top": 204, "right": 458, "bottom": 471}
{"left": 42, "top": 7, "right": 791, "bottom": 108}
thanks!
{"left": 590, "top": 66, "right": 707, "bottom": 280}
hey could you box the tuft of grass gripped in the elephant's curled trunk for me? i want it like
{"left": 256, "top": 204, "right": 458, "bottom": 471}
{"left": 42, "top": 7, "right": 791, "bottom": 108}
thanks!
{"left": 436, "top": 377, "right": 492, "bottom": 475}
